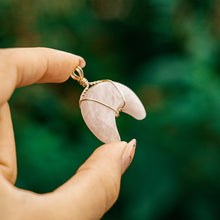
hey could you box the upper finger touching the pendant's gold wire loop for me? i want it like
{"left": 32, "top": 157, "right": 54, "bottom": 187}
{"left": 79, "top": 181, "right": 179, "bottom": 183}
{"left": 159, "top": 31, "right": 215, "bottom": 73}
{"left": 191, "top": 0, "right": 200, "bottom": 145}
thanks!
{"left": 0, "top": 48, "right": 85, "bottom": 105}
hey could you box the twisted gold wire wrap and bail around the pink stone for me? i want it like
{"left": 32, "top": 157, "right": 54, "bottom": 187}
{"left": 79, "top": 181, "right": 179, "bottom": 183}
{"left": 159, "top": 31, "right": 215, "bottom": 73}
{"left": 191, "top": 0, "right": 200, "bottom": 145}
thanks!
{"left": 71, "top": 66, "right": 126, "bottom": 117}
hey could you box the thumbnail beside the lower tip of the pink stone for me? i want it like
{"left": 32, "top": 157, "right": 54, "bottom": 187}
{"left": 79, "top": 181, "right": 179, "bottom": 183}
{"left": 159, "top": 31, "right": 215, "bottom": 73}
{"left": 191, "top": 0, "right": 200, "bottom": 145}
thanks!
{"left": 121, "top": 139, "right": 136, "bottom": 174}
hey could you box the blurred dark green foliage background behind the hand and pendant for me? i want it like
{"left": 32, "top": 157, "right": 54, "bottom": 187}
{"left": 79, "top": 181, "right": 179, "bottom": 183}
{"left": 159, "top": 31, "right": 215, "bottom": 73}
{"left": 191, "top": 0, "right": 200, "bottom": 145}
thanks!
{"left": 0, "top": 0, "right": 220, "bottom": 220}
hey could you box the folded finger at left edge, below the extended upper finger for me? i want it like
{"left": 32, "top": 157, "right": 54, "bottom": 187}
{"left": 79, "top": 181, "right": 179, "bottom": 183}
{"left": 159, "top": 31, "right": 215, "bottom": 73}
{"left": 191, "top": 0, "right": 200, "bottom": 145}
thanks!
{"left": 0, "top": 103, "right": 17, "bottom": 184}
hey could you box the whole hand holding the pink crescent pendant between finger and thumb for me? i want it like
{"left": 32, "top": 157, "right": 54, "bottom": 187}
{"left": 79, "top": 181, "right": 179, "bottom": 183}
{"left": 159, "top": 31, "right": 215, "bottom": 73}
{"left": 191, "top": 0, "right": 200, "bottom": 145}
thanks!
{"left": 0, "top": 48, "right": 136, "bottom": 220}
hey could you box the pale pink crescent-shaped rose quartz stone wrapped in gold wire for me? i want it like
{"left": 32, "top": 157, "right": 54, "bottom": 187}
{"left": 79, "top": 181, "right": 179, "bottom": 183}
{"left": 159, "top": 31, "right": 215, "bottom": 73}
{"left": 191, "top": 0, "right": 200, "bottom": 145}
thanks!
{"left": 81, "top": 82, "right": 146, "bottom": 143}
